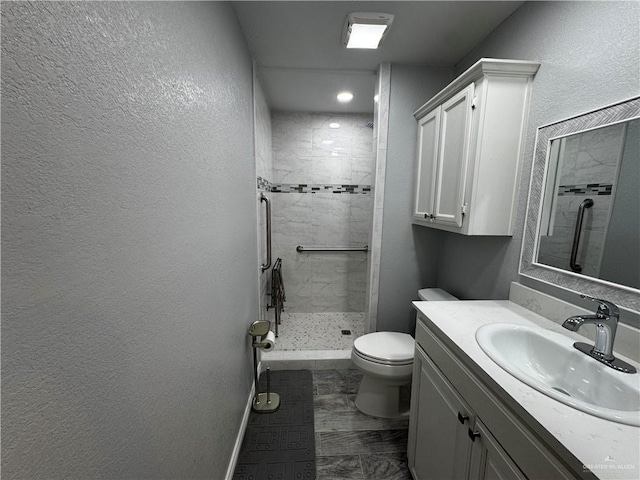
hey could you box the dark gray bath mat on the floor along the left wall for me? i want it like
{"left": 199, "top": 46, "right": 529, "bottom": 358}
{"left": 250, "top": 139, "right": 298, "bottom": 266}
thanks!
{"left": 233, "top": 370, "right": 316, "bottom": 480}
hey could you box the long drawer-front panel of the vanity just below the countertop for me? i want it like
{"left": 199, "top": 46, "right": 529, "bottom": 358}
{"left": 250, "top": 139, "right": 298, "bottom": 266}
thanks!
{"left": 416, "top": 314, "right": 580, "bottom": 479}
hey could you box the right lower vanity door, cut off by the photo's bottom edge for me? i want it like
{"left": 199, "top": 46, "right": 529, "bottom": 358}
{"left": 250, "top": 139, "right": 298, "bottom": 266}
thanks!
{"left": 469, "top": 419, "right": 527, "bottom": 480}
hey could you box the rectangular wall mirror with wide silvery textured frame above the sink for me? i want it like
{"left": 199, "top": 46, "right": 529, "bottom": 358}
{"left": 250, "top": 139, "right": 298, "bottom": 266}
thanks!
{"left": 520, "top": 97, "right": 640, "bottom": 312}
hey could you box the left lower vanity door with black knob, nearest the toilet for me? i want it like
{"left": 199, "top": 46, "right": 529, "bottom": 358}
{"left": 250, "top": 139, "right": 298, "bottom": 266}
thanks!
{"left": 408, "top": 346, "right": 474, "bottom": 480}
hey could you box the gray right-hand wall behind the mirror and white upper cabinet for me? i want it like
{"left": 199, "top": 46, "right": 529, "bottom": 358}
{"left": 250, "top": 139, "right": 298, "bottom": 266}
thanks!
{"left": 438, "top": 2, "right": 640, "bottom": 302}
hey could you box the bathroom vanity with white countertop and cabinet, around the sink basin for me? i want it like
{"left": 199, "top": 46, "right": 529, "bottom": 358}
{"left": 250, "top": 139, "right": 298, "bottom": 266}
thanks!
{"left": 408, "top": 300, "right": 640, "bottom": 480}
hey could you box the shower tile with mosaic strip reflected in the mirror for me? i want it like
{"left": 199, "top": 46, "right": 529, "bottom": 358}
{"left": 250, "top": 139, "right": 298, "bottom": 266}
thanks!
{"left": 538, "top": 125, "right": 625, "bottom": 277}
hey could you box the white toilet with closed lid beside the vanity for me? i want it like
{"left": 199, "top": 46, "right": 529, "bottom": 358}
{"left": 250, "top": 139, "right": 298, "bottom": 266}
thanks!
{"left": 351, "top": 288, "right": 457, "bottom": 418}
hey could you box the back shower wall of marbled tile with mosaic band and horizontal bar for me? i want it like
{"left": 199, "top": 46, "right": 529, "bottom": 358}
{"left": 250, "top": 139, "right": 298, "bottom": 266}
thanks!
{"left": 270, "top": 112, "right": 375, "bottom": 313}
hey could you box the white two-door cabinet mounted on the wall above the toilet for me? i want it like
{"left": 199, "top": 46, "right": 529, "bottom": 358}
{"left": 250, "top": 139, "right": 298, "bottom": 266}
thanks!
{"left": 413, "top": 59, "right": 540, "bottom": 235}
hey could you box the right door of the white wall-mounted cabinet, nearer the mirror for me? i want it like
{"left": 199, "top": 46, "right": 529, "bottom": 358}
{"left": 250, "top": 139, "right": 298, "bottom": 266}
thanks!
{"left": 433, "top": 84, "right": 473, "bottom": 227}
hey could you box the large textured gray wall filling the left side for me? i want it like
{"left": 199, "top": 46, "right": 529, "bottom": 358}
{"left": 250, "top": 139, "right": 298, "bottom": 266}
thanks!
{"left": 2, "top": 2, "right": 258, "bottom": 479}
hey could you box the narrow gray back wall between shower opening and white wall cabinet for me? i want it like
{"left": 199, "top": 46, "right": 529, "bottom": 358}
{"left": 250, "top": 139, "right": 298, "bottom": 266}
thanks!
{"left": 377, "top": 65, "right": 454, "bottom": 333}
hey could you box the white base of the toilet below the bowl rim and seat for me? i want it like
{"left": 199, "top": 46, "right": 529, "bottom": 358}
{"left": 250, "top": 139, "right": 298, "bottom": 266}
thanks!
{"left": 356, "top": 374, "right": 410, "bottom": 418}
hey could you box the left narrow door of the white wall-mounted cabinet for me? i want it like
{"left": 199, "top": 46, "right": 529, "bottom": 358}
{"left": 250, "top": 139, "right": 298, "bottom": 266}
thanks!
{"left": 413, "top": 108, "right": 441, "bottom": 219}
